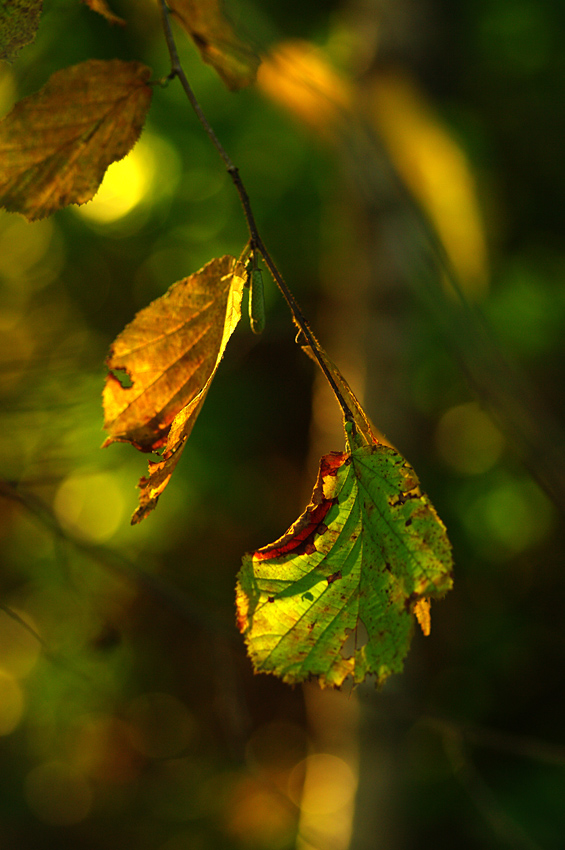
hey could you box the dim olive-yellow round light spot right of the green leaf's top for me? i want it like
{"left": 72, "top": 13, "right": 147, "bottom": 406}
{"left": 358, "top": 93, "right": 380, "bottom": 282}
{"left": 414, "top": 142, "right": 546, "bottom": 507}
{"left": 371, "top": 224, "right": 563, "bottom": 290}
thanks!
{"left": 435, "top": 402, "right": 505, "bottom": 475}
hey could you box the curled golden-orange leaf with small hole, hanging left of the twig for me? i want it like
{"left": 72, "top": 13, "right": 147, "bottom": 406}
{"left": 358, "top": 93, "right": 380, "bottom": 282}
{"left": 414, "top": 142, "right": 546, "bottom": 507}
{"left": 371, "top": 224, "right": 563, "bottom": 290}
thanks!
{"left": 104, "top": 255, "right": 246, "bottom": 523}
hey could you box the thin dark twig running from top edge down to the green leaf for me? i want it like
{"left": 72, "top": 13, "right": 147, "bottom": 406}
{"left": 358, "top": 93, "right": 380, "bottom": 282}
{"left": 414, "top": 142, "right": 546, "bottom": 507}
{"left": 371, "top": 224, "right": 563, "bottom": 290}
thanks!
{"left": 159, "top": 0, "right": 355, "bottom": 429}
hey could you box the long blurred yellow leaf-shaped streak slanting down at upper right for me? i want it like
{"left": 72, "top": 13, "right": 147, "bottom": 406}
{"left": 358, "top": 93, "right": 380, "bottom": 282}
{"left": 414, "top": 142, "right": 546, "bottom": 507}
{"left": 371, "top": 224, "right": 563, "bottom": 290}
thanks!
{"left": 368, "top": 73, "right": 488, "bottom": 295}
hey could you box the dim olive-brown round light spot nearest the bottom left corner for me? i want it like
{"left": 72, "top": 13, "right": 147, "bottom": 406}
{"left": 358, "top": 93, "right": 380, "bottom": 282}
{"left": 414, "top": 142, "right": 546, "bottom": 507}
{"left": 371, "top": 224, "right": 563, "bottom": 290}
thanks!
{"left": 25, "top": 761, "right": 92, "bottom": 826}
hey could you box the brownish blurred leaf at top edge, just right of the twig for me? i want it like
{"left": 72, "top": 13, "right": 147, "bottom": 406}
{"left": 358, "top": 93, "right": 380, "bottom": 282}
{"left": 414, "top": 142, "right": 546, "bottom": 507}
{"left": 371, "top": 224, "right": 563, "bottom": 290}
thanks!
{"left": 168, "top": 0, "right": 260, "bottom": 91}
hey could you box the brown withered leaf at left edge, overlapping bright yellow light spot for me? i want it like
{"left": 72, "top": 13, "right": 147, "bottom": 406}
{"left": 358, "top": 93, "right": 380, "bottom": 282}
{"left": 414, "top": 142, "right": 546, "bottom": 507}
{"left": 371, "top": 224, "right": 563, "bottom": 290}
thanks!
{"left": 0, "top": 59, "right": 152, "bottom": 221}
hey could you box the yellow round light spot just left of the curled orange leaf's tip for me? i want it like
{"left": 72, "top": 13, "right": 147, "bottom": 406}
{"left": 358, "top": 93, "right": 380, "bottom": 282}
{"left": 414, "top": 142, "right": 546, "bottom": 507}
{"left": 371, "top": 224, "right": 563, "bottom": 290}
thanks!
{"left": 53, "top": 471, "right": 125, "bottom": 543}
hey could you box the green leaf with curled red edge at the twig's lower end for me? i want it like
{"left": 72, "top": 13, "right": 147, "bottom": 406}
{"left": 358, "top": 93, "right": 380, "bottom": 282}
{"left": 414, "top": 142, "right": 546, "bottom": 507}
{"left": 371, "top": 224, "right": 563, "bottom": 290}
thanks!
{"left": 237, "top": 423, "right": 452, "bottom": 687}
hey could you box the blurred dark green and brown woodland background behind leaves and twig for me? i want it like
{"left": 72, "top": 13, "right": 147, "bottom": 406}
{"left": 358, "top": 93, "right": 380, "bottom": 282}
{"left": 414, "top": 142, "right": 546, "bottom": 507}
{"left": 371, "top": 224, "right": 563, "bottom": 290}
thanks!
{"left": 0, "top": 0, "right": 565, "bottom": 850}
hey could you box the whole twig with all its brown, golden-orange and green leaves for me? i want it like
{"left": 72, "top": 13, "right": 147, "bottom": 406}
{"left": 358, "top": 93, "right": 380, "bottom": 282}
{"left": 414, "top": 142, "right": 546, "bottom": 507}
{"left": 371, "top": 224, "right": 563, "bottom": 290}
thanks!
{"left": 0, "top": 0, "right": 452, "bottom": 687}
